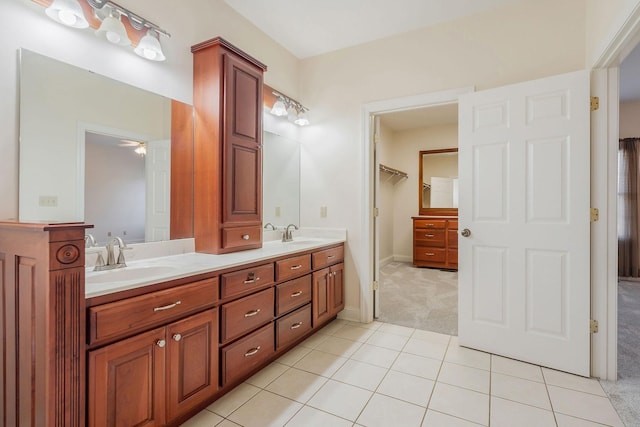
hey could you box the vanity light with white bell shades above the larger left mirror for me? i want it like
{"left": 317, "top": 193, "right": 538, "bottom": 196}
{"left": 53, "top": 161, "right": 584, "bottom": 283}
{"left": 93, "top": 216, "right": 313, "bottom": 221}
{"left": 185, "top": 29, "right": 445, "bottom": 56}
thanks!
{"left": 32, "top": 0, "right": 171, "bottom": 61}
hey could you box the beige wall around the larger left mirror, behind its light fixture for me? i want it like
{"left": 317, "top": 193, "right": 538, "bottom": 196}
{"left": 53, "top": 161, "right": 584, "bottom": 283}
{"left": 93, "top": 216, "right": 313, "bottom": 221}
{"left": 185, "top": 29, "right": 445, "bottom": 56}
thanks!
{"left": 0, "top": 0, "right": 299, "bottom": 219}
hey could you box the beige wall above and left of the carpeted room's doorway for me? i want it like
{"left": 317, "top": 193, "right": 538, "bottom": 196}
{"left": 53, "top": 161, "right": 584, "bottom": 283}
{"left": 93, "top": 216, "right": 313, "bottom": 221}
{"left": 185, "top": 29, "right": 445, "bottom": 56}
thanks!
{"left": 300, "top": 0, "right": 585, "bottom": 320}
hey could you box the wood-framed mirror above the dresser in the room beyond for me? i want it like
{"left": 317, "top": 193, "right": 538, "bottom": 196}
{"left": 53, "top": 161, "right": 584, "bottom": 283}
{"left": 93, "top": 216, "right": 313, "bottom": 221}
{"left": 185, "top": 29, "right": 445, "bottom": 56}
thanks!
{"left": 418, "top": 148, "right": 458, "bottom": 215}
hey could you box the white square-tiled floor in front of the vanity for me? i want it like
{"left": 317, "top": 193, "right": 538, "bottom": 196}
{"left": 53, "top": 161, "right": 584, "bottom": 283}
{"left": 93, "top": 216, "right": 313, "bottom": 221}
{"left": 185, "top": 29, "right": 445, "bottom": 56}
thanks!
{"left": 184, "top": 320, "right": 623, "bottom": 427}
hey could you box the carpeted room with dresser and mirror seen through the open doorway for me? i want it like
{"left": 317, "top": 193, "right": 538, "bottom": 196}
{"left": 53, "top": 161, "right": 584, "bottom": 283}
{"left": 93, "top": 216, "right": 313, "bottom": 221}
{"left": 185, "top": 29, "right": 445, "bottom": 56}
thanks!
{"left": 376, "top": 104, "right": 458, "bottom": 335}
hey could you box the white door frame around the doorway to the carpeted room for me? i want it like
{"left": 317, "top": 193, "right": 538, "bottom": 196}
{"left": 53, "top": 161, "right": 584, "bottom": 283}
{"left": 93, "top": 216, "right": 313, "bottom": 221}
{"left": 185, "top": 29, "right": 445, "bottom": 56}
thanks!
{"left": 360, "top": 86, "right": 474, "bottom": 323}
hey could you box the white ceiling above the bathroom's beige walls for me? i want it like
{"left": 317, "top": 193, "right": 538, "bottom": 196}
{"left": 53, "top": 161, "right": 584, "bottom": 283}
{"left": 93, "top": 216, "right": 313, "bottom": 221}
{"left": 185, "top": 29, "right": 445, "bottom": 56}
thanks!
{"left": 225, "top": 0, "right": 530, "bottom": 58}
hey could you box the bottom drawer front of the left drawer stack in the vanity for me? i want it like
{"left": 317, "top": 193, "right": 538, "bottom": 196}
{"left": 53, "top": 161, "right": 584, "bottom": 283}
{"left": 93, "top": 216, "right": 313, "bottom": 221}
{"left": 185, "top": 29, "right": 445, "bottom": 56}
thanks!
{"left": 221, "top": 322, "right": 275, "bottom": 386}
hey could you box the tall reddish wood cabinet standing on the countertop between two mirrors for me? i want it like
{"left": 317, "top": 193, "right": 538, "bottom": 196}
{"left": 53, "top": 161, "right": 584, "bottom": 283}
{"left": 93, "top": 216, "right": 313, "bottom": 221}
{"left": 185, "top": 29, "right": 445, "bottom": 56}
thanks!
{"left": 191, "top": 37, "right": 267, "bottom": 254}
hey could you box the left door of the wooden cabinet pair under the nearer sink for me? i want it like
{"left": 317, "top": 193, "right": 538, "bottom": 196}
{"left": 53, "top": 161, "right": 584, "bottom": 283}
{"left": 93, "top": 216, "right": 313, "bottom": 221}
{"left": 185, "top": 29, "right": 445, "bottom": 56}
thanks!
{"left": 87, "top": 328, "right": 166, "bottom": 427}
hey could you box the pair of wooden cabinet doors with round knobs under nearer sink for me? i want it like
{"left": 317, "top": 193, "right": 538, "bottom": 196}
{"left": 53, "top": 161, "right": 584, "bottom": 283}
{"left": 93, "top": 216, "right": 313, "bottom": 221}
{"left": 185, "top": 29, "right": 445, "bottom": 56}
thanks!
{"left": 88, "top": 309, "right": 218, "bottom": 426}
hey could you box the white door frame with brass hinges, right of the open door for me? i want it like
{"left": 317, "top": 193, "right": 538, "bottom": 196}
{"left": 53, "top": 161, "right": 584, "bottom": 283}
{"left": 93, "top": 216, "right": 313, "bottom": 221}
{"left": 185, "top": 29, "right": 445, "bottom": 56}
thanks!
{"left": 590, "top": 5, "right": 640, "bottom": 381}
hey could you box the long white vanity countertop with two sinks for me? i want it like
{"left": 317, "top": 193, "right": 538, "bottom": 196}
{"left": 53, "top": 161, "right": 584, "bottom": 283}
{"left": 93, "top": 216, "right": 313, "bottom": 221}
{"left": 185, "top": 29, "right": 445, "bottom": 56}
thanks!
{"left": 85, "top": 237, "right": 345, "bottom": 298}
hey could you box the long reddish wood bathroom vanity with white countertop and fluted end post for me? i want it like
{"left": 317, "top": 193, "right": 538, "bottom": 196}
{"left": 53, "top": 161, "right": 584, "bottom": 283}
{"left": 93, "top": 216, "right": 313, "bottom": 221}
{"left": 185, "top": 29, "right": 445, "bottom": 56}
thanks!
{"left": 0, "top": 223, "right": 344, "bottom": 426}
